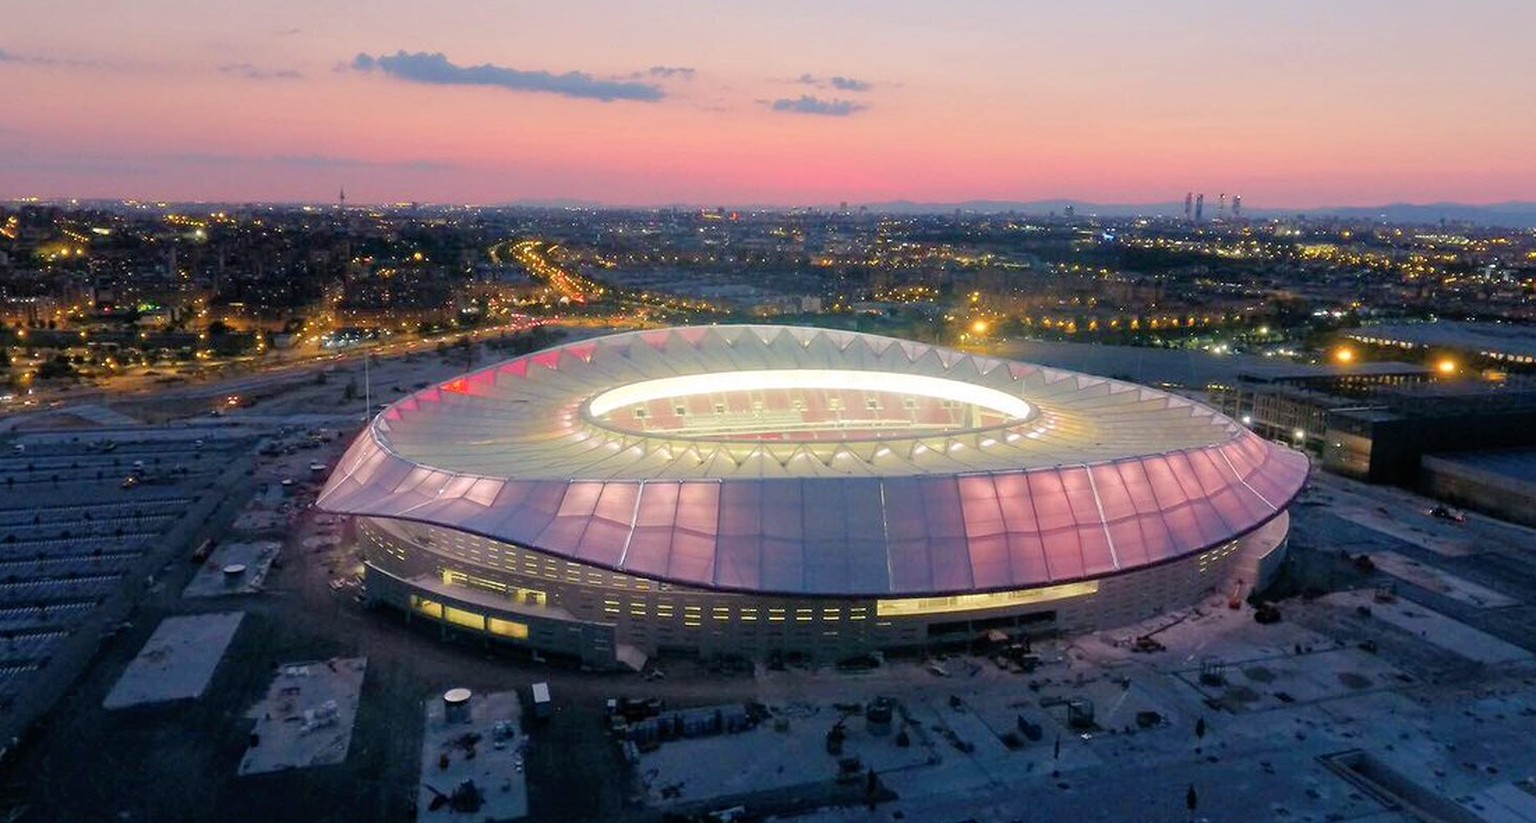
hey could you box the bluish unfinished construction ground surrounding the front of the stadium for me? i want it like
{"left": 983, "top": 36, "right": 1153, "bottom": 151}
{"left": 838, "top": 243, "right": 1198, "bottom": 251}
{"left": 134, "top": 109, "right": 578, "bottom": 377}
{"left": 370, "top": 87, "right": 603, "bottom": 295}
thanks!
{"left": 0, "top": 336, "right": 1536, "bottom": 823}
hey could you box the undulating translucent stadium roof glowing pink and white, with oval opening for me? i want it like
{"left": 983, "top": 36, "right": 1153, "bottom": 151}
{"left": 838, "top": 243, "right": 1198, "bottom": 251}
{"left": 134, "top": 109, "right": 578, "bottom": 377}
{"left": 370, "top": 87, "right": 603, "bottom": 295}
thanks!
{"left": 319, "top": 326, "right": 1307, "bottom": 596}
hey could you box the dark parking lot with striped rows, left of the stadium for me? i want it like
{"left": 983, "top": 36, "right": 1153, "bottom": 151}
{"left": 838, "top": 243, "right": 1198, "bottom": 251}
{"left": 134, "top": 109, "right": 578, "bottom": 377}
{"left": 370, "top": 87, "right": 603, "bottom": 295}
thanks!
{"left": 0, "top": 428, "right": 247, "bottom": 735}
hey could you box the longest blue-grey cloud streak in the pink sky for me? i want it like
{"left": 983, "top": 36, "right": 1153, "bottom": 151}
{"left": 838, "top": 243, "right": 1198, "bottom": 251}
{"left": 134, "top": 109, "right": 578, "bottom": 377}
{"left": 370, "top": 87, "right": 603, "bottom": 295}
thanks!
{"left": 352, "top": 51, "right": 665, "bottom": 103}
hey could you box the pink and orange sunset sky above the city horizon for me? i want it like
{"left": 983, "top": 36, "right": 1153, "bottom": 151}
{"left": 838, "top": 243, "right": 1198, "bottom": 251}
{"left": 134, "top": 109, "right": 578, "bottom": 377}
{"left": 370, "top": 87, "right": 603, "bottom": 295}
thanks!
{"left": 0, "top": 0, "right": 1536, "bottom": 209}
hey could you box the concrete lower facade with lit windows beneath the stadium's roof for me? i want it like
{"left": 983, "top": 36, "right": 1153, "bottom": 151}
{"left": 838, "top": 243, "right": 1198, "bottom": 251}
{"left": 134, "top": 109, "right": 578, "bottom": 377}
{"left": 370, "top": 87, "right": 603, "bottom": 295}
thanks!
{"left": 358, "top": 514, "right": 1289, "bottom": 668}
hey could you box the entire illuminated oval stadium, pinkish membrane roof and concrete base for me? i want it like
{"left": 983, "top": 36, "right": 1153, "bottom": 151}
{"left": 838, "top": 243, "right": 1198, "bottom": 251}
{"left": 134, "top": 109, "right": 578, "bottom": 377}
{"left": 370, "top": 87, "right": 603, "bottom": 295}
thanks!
{"left": 318, "top": 326, "right": 1309, "bottom": 668}
